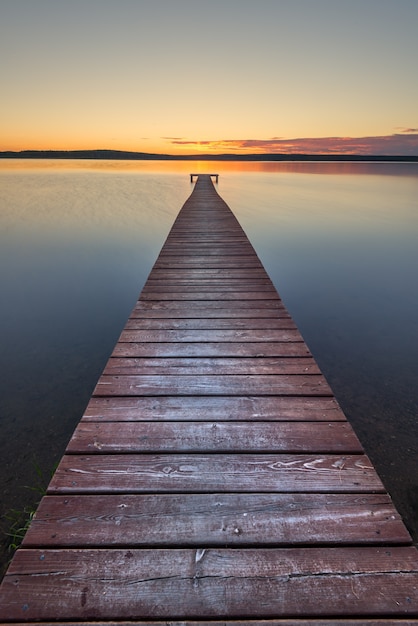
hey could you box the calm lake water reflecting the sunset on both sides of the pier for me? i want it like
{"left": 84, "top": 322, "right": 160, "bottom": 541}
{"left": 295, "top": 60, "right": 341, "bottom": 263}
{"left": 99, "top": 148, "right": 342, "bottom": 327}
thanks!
{"left": 0, "top": 160, "right": 418, "bottom": 572}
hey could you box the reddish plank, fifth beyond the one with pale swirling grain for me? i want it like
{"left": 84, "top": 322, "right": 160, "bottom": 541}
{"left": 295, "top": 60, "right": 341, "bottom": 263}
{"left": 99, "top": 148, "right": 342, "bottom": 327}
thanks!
{"left": 112, "top": 341, "right": 311, "bottom": 356}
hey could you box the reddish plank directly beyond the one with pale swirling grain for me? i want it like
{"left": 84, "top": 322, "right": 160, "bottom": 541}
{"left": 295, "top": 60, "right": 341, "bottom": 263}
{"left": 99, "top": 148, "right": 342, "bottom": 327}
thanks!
{"left": 67, "top": 421, "right": 363, "bottom": 454}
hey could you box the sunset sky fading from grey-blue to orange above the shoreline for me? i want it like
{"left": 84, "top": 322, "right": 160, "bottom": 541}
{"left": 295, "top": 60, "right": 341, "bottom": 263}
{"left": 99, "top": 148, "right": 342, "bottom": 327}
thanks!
{"left": 0, "top": 0, "right": 418, "bottom": 155}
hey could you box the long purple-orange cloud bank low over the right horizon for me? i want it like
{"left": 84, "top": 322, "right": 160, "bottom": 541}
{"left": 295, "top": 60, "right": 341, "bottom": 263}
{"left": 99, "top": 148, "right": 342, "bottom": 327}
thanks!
{"left": 172, "top": 128, "right": 418, "bottom": 156}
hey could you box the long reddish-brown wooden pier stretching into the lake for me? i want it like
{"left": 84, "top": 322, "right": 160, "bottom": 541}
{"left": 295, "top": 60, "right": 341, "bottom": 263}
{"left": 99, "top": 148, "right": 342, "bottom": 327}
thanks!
{"left": 0, "top": 175, "right": 418, "bottom": 626}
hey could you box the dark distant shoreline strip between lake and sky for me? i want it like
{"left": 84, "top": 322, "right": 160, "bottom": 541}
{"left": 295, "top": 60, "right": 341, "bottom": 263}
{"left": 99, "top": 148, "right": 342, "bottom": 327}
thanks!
{"left": 0, "top": 150, "right": 418, "bottom": 163}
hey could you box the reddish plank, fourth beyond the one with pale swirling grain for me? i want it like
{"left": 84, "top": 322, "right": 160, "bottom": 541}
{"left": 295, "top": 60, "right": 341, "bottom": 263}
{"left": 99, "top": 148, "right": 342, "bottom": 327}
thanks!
{"left": 103, "top": 357, "right": 320, "bottom": 376}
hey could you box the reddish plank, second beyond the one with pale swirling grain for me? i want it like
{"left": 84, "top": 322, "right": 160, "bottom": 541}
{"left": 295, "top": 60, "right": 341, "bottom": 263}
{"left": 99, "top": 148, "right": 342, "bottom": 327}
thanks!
{"left": 82, "top": 396, "right": 346, "bottom": 422}
